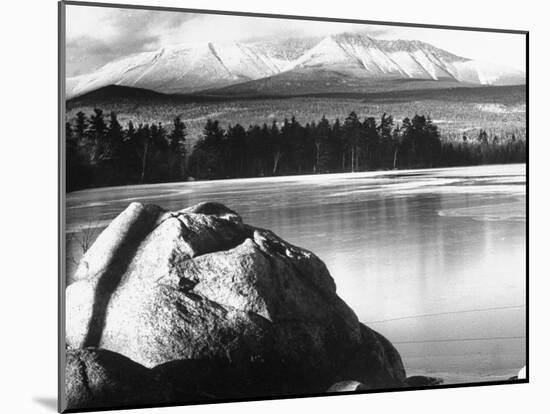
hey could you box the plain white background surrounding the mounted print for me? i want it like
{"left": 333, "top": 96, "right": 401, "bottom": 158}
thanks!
{"left": 0, "top": 0, "right": 550, "bottom": 414}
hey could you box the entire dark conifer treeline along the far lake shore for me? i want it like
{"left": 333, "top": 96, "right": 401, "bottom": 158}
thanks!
{"left": 66, "top": 109, "right": 526, "bottom": 191}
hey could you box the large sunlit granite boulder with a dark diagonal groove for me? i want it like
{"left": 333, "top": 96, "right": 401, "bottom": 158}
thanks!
{"left": 66, "top": 203, "right": 406, "bottom": 397}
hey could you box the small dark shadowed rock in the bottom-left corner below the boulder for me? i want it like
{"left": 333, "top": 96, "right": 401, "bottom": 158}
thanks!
{"left": 65, "top": 348, "right": 162, "bottom": 409}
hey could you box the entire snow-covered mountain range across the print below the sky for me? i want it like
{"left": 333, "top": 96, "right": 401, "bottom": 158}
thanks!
{"left": 66, "top": 33, "right": 525, "bottom": 98}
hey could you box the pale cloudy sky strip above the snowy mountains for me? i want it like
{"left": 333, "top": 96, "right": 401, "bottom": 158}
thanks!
{"left": 66, "top": 5, "right": 525, "bottom": 76}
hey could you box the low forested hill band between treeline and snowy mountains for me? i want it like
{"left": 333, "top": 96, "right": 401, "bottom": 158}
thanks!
{"left": 66, "top": 85, "right": 526, "bottom": 145}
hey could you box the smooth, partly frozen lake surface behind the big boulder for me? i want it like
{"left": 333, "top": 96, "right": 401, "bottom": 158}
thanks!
{"left": 66, "top": 165, "right": 527, "bottom": 383}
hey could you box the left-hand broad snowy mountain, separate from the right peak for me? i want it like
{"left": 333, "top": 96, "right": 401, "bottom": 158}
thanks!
{"left": 67, "top": 42, "right": 300, "bottom": 98}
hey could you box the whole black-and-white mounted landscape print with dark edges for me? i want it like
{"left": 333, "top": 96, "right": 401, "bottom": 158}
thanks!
{"left": 59, "top": 1, "right": 528, "bottom": 411}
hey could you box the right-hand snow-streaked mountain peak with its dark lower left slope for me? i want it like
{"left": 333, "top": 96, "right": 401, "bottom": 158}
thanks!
{"left": 206, "top": 33, "right": 525, "bottom": 96}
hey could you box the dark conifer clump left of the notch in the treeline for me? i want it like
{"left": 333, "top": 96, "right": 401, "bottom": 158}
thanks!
{"left": 65, "top": 109, "right": 187, "bottom": 191}
